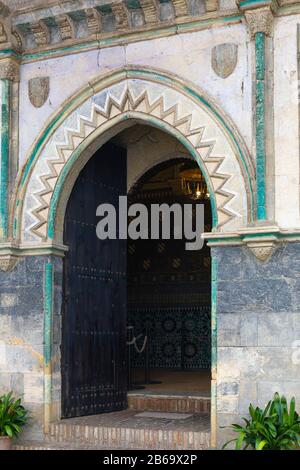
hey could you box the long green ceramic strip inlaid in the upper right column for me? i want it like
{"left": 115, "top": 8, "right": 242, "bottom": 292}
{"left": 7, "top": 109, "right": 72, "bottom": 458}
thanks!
{"left": 255, "top": 33, "right": 266, "bottom": 220}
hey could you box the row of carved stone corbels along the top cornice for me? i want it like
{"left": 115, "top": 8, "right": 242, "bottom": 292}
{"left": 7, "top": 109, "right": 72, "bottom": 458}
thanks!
{"left": 10, "top": 0, "right": 238, "bottom": 50}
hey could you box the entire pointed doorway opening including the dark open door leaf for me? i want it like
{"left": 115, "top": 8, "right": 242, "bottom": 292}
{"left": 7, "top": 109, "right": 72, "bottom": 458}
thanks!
{"left": 61, "top": 124, "right": 211, "bottom": 418}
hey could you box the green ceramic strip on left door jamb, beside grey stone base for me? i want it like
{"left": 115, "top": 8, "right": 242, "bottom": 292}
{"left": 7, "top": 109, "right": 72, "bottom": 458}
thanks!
{"left": 44, "top": 262, "right": 53, "bottom": 366}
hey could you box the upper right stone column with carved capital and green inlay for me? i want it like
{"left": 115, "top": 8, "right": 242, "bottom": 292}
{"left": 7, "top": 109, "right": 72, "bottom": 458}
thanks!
{"left": 239, "top": 0, "right": 277, "bottom": 222}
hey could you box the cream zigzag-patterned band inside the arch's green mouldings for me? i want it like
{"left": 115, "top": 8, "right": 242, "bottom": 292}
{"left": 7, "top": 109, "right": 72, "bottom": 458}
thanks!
{"left": 22, "top": 79, "right": 247, "bottom": 241}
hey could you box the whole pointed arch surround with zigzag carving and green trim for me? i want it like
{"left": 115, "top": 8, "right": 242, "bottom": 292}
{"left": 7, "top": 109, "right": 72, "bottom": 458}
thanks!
{"left": 17, "top": 70, "right": 253, "bottom": 244}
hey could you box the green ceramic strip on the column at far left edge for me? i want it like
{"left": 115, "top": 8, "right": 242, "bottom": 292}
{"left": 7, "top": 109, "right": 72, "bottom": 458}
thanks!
{"left": 0, "top": 79, "right": 10, "bottom": 238}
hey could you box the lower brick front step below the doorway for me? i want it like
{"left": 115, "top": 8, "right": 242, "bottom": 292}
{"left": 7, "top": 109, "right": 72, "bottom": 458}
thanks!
{"left": 47, "top": 410, "right": 210, "bottom": 450}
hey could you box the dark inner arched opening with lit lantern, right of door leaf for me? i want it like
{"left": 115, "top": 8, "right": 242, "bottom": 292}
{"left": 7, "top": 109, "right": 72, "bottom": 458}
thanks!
{"left": 127, "top": 157, "right": 211, "bottom": 396}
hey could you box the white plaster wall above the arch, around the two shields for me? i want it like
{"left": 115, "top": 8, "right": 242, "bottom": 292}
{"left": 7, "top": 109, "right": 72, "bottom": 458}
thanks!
{"left": 20, "top": 25, "right": 252, "bottom": 165}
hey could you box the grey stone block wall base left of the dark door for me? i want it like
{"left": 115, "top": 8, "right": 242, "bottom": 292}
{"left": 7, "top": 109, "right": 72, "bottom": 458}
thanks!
{"left": 0, "top": 256, "right": 62, "bottom": 439}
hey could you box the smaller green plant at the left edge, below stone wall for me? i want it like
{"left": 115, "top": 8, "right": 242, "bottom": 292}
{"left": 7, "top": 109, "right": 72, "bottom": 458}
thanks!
{"left": 0, "top": 392, "right": 28, "bottom": 437}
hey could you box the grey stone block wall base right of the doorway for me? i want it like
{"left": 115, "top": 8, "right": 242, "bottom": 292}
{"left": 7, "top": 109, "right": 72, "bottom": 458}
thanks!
{"left": 212, "top": 243, "right": 300, "bottom": 446}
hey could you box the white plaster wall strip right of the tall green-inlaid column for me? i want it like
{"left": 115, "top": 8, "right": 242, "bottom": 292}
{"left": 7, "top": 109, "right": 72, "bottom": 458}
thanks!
{"left": 274, "top": 15, "right": 300, "bottom": 228}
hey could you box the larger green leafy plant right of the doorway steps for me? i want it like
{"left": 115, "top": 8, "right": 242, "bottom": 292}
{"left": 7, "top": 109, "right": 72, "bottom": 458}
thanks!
{"left": 223, "top": 393, "right": 300, "bottom": 450}
